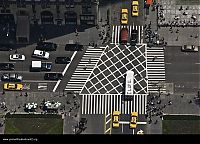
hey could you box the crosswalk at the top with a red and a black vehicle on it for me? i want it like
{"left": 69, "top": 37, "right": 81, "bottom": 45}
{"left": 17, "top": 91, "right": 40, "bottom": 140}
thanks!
{"left": 111, "top": 25, "right": 144, "bottom": 45}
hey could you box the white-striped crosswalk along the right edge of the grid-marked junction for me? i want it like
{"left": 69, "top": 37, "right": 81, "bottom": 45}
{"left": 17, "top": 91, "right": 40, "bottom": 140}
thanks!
{"left": 147, "top": 47, "right": 166, "bottom": 92}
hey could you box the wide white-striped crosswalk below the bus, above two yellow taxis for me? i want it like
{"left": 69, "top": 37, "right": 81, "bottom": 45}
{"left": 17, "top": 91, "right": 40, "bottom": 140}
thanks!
{"left": 81, "top": 94, "right": 147, "bottom": 114}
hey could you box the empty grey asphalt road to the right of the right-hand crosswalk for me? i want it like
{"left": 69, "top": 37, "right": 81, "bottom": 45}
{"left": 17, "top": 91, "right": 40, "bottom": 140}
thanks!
{"left": 165, "top": 47, "right": 200, "bottom": 94}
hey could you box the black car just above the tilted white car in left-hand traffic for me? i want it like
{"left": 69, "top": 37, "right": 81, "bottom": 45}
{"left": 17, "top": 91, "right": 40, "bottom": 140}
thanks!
{"left": 36, "top": 42, "right": 58, "bottom": 51}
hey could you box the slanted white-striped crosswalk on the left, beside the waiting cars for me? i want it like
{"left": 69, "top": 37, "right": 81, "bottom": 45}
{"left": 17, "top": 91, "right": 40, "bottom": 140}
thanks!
{"left": 65, "top": 46, "right": 104, "bottom": 92}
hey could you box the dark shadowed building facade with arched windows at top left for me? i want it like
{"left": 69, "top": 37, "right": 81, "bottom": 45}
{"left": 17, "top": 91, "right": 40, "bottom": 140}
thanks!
{"left": 0, "top": 0, "right": 99, "bottom": 25}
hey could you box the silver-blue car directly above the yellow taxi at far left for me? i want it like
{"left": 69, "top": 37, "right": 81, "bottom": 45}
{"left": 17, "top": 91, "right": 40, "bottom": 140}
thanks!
{"left": 1, "top": 73, "right": 23, "bottom": 82}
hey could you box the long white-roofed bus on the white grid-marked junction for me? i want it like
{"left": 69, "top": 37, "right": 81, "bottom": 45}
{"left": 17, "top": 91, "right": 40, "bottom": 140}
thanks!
{"left": 125, "top": 70, "right": 134, "bottom": 96}
